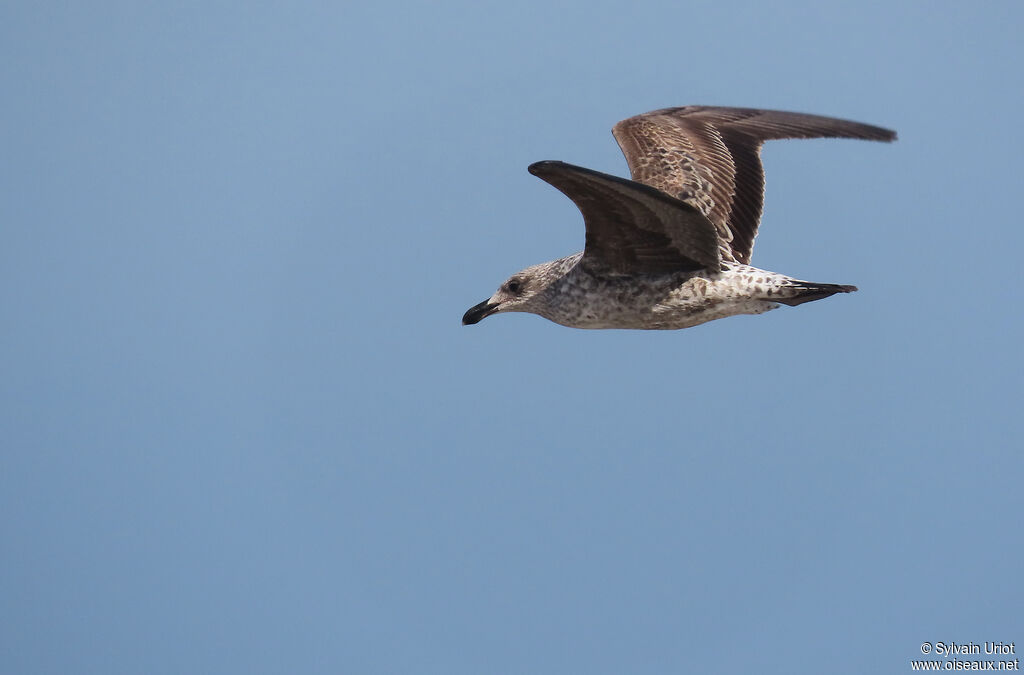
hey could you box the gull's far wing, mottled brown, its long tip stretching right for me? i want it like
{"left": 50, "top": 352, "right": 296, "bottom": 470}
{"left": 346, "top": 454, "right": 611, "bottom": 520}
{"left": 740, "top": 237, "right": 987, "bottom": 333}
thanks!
{"left": 611, "top": 106, "right": 896, "bottom": 264}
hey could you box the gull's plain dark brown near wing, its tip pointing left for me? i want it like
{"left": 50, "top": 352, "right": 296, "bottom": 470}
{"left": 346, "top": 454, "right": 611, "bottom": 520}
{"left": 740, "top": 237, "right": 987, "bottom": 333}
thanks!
{"left": 529, "top": 162, "right": 721, "bottom": 275}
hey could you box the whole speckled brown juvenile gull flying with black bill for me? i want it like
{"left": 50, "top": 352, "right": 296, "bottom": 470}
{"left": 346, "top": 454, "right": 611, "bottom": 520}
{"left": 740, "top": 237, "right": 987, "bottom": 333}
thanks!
{"left": 462, "top": 106, "right": 896, "bottom": 329}
